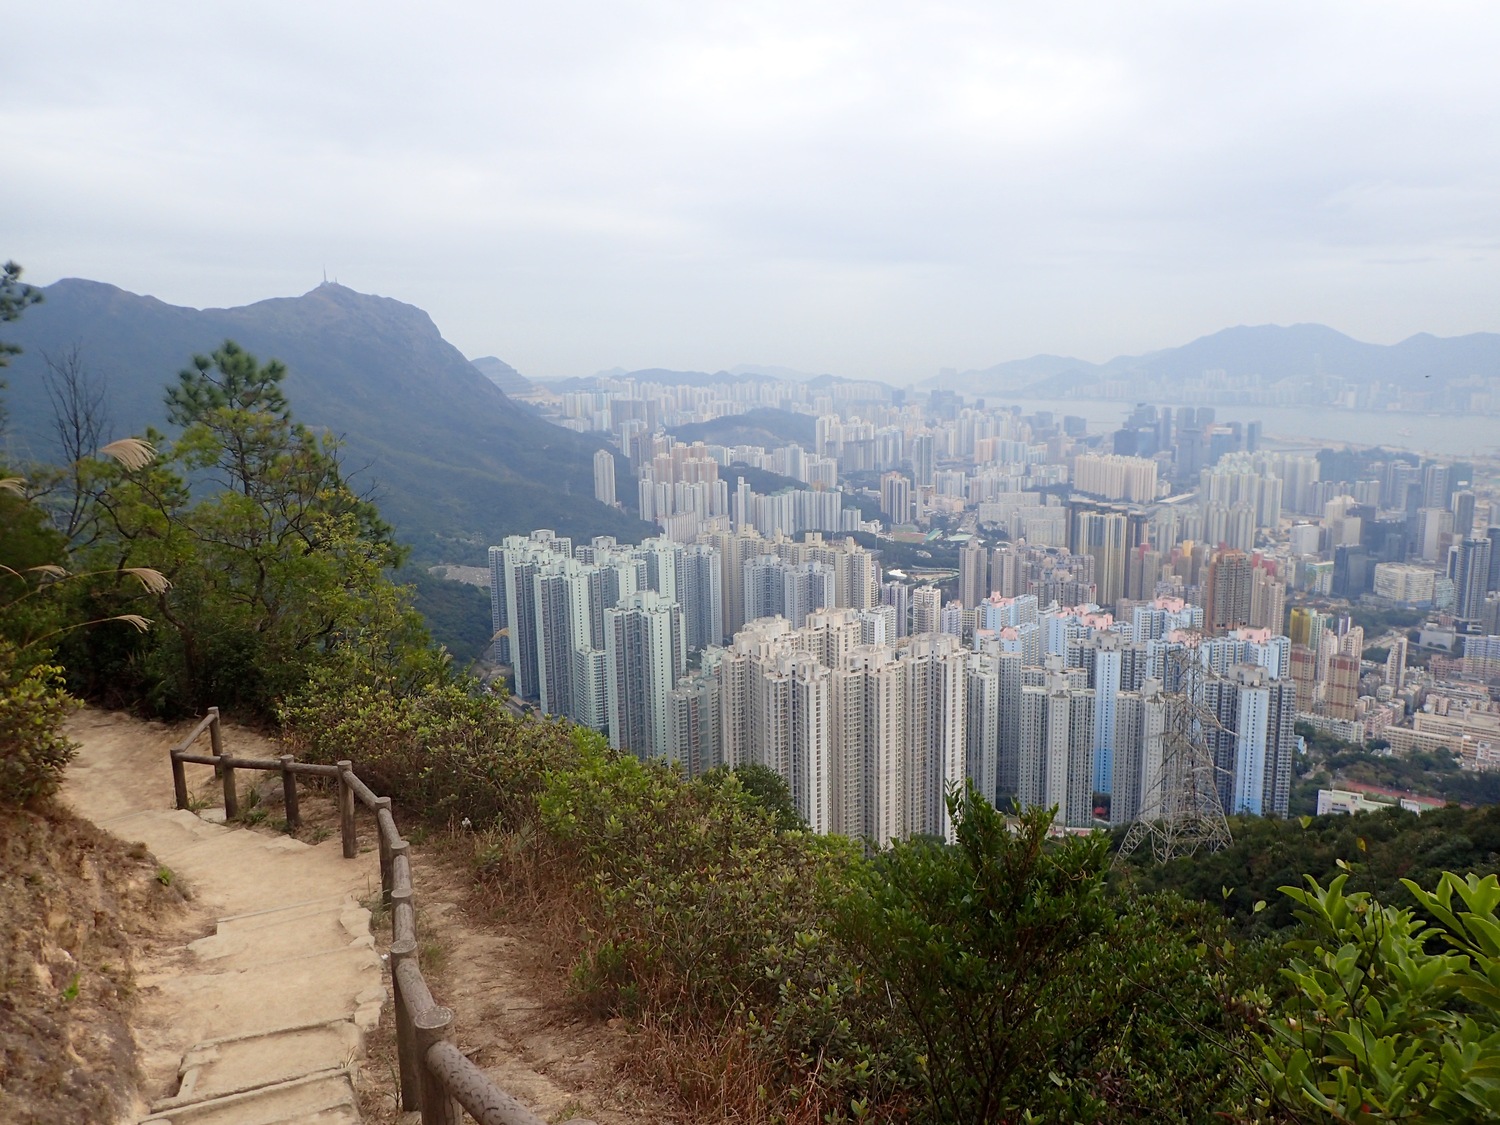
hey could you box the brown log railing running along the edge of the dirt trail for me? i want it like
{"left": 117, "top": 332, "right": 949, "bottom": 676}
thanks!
{"left": 171, "top": 707, "right": 591, "bottom": 1125}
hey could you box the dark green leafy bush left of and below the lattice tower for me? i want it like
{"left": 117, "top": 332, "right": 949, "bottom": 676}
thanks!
{"left": 836, "top": 788, "right": 1272, "bottom": 1122}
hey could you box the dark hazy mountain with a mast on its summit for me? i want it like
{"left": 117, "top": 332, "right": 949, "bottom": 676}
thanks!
{"left": 3, "top": 279, "right": 650, "bottom": 563}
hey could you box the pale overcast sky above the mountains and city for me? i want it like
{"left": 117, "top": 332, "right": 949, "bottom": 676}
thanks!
{"left": 11, "top": 0, "right": 1500, "bottom": 383}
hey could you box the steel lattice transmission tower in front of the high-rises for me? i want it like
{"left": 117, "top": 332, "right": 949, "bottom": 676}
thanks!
{"left": 1116, "top": 648, "right": 1230, "bottom": 863}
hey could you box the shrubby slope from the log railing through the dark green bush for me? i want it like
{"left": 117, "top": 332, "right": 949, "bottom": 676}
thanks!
{"left": 285, "top": 687, "right": 1265, "bottom": 1122}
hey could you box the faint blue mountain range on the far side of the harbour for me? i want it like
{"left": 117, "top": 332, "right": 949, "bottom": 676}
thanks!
{"left": 929, "top": 324, "right": 1500, "bottom": 398}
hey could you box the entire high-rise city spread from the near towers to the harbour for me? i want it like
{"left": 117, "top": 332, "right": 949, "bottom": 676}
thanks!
{"left": 504, "top": 380, "right": 1500, "bottom": 840}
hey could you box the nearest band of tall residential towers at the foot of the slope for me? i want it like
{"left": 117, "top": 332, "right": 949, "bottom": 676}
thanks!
{"left": 491, "top": 528, "right": 1296, "bottom": 840}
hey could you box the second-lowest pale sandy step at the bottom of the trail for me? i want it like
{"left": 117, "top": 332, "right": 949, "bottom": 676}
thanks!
{"left": 152, "top": 1020, "right": 365, "bottom": 1112}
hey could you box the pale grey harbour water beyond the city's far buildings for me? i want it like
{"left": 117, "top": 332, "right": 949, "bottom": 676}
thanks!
{"left": 1014, "top": 399, "right": 1500, "bottom": 458}
